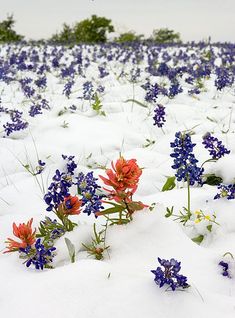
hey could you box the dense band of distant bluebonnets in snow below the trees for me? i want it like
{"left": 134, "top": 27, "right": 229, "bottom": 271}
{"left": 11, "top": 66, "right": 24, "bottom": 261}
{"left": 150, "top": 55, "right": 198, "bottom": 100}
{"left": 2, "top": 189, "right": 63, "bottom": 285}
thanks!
{"left": 0, "top": 43, "right": 234, "bottom": 136}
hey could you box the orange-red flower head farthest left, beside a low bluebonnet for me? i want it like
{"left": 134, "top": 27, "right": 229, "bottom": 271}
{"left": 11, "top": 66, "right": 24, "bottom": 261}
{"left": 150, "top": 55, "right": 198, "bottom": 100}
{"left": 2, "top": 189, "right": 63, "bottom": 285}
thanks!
{"left": 4, "top": 218, "right": 36, "bottom": 253}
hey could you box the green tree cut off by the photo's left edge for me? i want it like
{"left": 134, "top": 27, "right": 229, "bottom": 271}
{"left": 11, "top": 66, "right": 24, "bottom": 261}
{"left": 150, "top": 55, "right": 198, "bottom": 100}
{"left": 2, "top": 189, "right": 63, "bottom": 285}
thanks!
{"left": 0, "top": 15, "right": 24, "bottom": 43}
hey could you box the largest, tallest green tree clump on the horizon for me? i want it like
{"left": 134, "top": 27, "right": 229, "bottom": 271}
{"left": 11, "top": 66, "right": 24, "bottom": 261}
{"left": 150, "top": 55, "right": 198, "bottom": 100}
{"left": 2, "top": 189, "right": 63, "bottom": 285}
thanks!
{"left": 51, "top": 15, "right": 114, "bottom": 44}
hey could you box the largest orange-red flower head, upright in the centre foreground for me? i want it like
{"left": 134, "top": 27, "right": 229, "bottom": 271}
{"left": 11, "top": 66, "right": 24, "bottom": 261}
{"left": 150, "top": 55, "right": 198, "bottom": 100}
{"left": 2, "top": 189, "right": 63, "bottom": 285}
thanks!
{"left": 100, "top": 157, "right": 142, "bottom": 194}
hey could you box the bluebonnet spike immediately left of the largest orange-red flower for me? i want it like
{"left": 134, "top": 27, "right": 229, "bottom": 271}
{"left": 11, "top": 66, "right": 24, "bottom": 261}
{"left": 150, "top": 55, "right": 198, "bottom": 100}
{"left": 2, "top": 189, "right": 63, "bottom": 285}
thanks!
{"left": 77, "top": 172, "right": 104, "bottom": 215}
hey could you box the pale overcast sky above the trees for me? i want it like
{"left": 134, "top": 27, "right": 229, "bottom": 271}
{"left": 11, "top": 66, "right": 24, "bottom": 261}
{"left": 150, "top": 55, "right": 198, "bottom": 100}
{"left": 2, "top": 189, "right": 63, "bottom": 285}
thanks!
{"left": 0, "top": 0, "right": 235, "bottom": 42}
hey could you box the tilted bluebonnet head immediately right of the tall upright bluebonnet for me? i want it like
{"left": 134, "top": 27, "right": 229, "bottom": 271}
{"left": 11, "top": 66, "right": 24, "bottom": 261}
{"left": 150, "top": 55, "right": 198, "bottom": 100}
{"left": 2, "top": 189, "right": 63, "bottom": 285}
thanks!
{"left": 202, "top": 133, "right": 230, "bottom": 159}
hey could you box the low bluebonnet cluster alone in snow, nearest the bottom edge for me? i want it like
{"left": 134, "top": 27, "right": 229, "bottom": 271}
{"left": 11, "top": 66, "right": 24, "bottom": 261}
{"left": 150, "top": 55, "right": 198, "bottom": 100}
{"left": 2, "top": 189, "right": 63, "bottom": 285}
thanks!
{"left": 151, "top": 257, "right": 190, "bottom": 291}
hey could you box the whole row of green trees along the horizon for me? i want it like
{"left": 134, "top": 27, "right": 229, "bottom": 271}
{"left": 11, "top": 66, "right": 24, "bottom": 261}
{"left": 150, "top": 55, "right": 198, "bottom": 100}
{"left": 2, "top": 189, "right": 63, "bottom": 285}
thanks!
{"left": 0, "top": 15, "right": 181, "bottom": 44}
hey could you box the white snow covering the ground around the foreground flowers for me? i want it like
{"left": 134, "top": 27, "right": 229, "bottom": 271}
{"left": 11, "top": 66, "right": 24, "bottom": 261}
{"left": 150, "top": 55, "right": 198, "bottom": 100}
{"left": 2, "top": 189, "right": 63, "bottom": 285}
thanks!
{"left": 0, "top": 44, "right": 235, "bottom": 318}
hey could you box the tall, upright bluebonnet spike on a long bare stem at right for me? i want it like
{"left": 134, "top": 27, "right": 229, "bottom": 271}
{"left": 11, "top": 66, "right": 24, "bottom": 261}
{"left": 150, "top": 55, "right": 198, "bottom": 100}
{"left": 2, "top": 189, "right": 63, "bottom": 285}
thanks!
{"left": 170, "top": 132, "right": 204, "bottom": 185}
